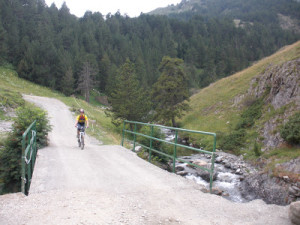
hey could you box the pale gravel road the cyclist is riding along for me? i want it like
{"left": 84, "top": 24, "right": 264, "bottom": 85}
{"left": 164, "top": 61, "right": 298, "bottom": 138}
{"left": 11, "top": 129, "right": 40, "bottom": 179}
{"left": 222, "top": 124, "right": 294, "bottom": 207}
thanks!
{"left": 0, "top": 96, "right": 290, "bottom": 225}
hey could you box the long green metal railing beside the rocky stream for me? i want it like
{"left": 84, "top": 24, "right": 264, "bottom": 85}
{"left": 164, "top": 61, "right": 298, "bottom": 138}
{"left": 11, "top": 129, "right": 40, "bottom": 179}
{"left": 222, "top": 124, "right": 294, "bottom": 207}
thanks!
{"left": 121, "top": 120, "right": 217, "bottom": 192}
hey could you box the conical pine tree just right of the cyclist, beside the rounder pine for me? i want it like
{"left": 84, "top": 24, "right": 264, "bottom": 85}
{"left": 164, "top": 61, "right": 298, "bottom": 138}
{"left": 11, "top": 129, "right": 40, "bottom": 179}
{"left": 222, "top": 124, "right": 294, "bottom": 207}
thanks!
{"left": 106, "top": 59, "right": 151, "bottom": 125}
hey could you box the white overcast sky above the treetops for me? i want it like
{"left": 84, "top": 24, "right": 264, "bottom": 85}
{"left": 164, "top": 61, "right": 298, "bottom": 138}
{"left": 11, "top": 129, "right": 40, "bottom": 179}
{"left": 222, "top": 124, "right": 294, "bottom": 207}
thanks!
{"left": 46, "top": 0, "right": 181, "bottom": 17}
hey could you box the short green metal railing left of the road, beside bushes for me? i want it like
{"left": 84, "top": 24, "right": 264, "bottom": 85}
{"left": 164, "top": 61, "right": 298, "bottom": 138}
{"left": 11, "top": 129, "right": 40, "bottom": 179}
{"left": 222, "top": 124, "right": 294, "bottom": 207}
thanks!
{"left": 21, "top": 121, "right": 37, "bottom": 195}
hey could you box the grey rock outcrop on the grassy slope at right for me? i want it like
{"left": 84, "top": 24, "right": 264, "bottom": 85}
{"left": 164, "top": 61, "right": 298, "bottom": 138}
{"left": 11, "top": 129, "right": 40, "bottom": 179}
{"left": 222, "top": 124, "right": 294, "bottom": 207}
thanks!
{"left": 247, "top": 58, "right": 300, "bottom": 148}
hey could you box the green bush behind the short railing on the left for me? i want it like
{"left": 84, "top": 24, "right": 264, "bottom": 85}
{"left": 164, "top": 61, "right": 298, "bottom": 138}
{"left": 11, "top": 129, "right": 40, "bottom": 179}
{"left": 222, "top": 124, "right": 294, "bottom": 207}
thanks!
{"left": 0, "top": 105, "right": 50, "bottom": 193}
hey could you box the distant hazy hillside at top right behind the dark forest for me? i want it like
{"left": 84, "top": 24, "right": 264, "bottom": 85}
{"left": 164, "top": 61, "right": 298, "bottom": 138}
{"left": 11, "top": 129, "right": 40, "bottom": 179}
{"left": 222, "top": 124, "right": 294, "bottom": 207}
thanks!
{"left": 149, "top": 0, "right": 300, "bottom": 33}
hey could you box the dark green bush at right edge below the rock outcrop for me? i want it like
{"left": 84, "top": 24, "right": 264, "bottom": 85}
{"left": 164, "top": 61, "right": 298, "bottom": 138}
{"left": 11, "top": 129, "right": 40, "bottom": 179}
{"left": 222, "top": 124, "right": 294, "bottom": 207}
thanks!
{"left": 280, "top": 112, "right": 300, "bottom": 145}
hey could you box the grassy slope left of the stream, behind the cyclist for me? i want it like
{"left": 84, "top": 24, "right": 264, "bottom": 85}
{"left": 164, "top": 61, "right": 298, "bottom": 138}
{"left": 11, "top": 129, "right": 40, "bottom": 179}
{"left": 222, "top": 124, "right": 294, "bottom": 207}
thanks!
{"left": 0, "top": 67, "right": 121, "bottom": 144}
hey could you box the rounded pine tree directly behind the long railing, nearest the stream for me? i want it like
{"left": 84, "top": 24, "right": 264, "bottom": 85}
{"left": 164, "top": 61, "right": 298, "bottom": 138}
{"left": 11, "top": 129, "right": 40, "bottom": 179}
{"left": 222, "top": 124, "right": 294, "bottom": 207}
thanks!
{"left": 152, "top": 57, "right": 189, "bottom": 127}
